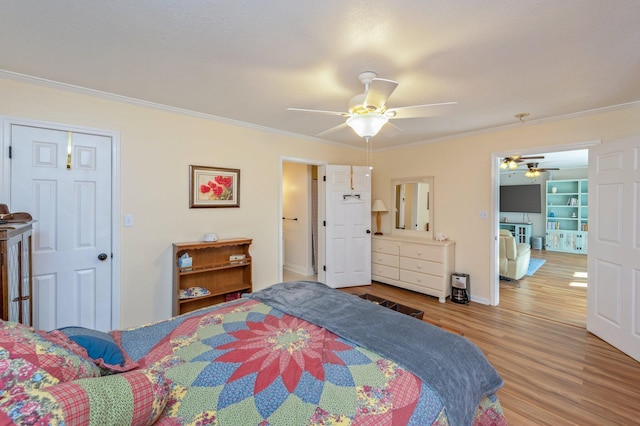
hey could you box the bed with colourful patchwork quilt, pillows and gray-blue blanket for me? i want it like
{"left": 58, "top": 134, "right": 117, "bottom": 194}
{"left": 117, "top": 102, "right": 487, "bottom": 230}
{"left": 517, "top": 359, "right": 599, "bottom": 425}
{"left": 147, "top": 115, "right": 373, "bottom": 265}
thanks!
{"left": 0, "top": 281, "right": 507, "bottom": 426}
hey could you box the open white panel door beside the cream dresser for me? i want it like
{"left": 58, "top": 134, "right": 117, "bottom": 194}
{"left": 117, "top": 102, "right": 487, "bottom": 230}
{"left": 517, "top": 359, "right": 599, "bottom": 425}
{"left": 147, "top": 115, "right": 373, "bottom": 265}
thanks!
{"left": 325, "top": 165, "right": 371, "bottom": 288}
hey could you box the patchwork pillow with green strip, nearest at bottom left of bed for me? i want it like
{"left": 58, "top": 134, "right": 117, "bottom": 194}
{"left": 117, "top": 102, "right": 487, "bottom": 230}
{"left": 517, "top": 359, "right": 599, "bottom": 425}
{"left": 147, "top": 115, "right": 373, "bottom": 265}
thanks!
{"left": 0, "top": 369, "right": 169, "bottom": 426}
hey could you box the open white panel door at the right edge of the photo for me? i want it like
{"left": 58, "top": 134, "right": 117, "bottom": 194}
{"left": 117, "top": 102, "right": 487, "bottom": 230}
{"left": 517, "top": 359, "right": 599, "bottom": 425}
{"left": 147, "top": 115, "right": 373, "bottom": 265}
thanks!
{"left": 587, "top": 136, "right": 640, "bottom": 361}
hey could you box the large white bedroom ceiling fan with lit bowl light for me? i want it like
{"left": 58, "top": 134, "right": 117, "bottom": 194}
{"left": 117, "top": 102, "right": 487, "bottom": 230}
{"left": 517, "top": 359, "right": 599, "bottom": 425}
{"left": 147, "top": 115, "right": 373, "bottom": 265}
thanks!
{"left": 287, "top": 71, "right": 457, "bottom": 142}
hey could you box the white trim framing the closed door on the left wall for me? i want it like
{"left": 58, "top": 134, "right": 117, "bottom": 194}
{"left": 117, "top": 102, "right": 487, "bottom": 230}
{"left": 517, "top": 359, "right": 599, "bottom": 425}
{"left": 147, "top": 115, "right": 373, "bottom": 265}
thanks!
{"left": 0, "top": 116, "right": 121, "bottom": 330}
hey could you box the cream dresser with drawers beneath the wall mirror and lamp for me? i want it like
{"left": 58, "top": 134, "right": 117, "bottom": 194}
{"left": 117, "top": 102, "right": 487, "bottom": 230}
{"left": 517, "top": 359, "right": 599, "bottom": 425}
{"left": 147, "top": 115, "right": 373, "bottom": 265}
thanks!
{"left": 371, "top": 236, "right": 455, "bottom": 303}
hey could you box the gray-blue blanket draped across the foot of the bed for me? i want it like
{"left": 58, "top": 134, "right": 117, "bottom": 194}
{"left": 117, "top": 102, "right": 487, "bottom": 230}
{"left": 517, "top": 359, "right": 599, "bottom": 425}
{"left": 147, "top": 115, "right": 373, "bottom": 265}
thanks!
{"left": 244, "top": 281, "right": 504, "bottom": 426}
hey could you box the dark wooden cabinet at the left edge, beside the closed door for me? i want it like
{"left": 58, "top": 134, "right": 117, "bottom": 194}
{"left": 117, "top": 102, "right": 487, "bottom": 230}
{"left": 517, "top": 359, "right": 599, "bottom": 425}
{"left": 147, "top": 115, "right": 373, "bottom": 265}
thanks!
{"left": 0, "top": 223, "right": 33, "bottom": 325}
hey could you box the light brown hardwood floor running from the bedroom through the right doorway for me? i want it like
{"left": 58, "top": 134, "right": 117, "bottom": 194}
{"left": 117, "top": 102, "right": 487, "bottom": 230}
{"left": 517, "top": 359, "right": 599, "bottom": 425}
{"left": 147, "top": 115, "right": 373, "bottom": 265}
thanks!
{"left": 343, "top": 250, "right": 640, "bottom": 426}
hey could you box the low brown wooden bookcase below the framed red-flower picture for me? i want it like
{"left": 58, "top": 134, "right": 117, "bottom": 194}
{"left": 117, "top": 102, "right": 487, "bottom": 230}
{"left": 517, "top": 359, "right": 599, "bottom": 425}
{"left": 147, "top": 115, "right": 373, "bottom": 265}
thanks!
{"left": 173, "top": 238, "right": 252, "bottom": 315}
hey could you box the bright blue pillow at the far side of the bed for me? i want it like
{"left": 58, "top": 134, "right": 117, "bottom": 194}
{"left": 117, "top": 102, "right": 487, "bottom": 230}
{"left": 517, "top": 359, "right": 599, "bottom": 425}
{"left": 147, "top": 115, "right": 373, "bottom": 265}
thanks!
{"left": 49, "top": 327, "right": 139, "bottom": 373}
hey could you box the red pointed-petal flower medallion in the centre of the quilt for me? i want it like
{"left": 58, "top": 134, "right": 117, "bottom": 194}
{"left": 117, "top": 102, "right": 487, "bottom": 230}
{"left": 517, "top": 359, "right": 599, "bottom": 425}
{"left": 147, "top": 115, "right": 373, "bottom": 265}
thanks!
{"left": 216, "top": 314, "right": 352, "bottom": 393}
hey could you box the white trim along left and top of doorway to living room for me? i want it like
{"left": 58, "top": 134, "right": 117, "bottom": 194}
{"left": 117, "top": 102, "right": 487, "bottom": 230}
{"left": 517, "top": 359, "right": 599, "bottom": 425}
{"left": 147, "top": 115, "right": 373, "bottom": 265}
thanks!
{"left": 489, "top": 140, "right": 601, "bottom": 306}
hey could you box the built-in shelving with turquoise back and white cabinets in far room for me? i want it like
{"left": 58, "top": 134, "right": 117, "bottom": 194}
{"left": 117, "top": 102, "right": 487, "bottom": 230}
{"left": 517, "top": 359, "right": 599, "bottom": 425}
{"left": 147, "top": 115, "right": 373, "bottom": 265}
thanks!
{"left": 545, "top": 179, "right": 589, "bottom": 254}
